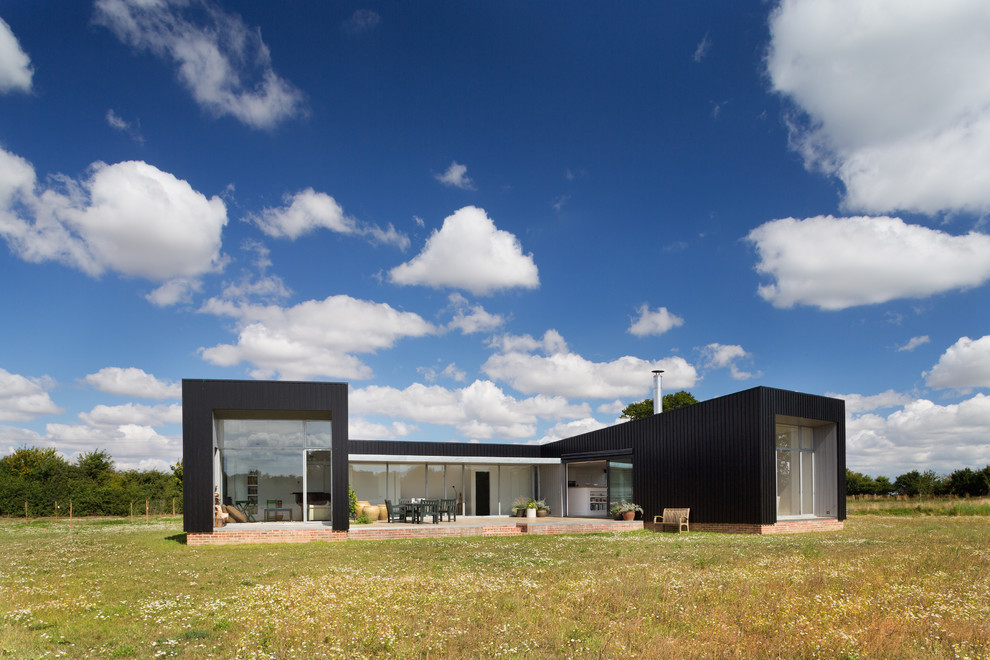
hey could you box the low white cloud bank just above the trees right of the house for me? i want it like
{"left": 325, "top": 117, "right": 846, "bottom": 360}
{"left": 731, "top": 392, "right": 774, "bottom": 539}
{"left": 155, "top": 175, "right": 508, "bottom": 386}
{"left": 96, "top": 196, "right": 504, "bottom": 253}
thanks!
{"left": 846, "top": 394, "right": 990, "bottom": 477}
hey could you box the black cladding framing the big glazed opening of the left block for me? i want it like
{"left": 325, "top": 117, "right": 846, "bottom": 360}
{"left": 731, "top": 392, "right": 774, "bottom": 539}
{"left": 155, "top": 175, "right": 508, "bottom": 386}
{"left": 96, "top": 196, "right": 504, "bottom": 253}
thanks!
{"left": 182, "top": 379, "right": 349, "bottom": 532}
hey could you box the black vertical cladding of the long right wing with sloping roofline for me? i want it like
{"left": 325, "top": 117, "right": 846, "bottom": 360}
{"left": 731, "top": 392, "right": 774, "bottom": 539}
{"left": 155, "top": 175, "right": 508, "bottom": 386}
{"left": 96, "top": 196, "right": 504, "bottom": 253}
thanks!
{"left": 542, "top": 387, "right": 846, "bottom": 524}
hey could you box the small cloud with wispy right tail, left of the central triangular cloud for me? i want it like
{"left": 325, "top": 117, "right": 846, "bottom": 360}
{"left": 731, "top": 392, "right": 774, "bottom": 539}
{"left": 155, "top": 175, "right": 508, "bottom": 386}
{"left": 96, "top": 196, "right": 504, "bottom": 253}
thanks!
{"left": 248, "top": 188, "right": 409, "bottom": 250}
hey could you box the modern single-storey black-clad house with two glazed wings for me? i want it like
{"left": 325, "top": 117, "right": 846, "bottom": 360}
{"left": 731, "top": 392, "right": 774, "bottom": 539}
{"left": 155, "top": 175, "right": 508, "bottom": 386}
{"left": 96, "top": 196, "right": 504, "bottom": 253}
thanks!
{"left": 182, "top": 380, "right": 846, "bottom": 534}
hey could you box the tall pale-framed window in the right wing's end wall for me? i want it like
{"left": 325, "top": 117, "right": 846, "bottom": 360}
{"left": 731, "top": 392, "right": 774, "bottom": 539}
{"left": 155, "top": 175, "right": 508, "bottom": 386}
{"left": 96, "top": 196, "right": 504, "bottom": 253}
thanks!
{"left": 776, "top": 424, "right": 815, "bottom": 516}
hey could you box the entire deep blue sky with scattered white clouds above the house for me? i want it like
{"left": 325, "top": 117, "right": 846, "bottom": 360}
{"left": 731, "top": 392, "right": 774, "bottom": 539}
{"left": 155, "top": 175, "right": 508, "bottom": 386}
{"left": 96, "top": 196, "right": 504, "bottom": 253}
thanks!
{"left": 0, "top": 0, "right": 990, "bottom": 476}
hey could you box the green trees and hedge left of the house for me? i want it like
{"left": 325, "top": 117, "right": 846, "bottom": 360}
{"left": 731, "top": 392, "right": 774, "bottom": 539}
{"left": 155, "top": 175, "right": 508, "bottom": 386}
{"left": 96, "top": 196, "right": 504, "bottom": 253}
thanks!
{"left": 0, "top": 447, "right": 182, "bottom": 517}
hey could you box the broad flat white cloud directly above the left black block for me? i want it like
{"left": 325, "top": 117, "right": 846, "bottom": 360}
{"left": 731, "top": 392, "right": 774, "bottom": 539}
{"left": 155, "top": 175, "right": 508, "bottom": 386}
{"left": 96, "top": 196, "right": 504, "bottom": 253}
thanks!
{"left": 200, "top": 295, "right": 436, "bottom": 380}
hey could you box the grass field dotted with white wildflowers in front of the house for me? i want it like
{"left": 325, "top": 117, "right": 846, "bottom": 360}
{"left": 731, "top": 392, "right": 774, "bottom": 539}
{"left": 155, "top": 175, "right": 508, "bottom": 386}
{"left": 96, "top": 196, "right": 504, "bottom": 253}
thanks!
{"left": 0, "top": 515, "right": 990, "bottom": 658}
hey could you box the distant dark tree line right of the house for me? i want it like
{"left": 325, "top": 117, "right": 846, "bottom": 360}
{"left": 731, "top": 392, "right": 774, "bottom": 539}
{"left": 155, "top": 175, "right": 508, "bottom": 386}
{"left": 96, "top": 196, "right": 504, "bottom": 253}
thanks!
{"left": 846, "top": 465, "right": 990, "bottom": 497}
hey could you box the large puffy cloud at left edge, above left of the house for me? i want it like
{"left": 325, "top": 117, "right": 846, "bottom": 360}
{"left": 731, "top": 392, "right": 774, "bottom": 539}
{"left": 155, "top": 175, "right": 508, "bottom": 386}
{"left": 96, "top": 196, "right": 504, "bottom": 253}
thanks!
{"left": 0, "top": 149, "right": 227, "bottom": 296}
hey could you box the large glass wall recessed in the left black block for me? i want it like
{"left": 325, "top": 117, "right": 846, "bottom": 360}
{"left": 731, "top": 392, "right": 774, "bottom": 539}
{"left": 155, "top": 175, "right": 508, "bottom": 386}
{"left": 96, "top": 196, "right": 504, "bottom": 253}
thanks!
{"left": 214, "top": 419, "right": 330, "bottom": 522}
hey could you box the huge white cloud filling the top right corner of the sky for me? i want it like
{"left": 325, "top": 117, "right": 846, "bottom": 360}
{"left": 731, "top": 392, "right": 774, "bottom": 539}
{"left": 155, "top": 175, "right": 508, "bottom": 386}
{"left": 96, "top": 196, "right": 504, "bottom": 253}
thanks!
{"left": 767, "top": 0, "right": 990, "bottom": 214}
